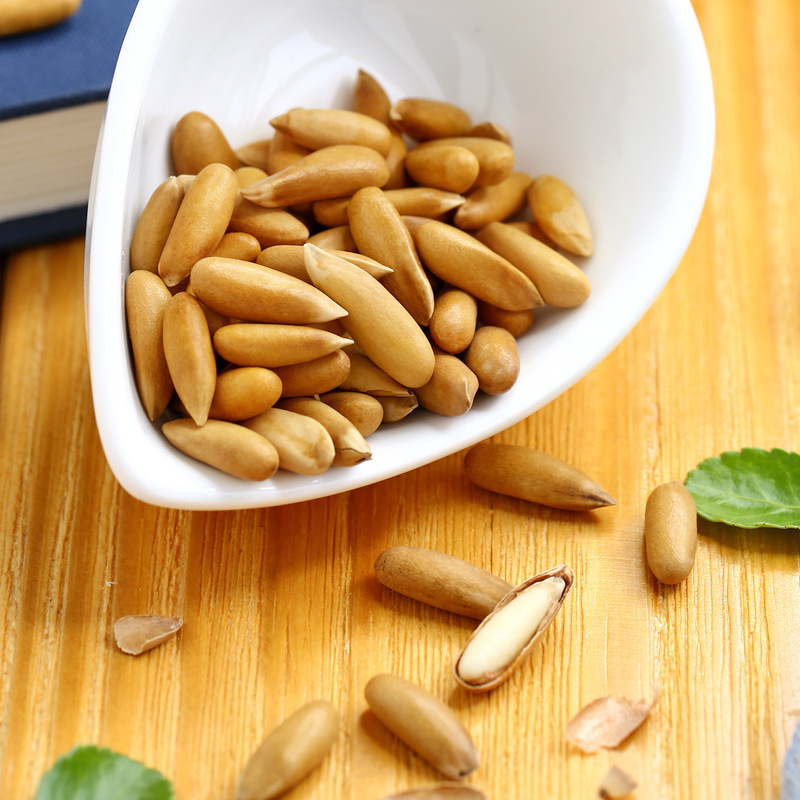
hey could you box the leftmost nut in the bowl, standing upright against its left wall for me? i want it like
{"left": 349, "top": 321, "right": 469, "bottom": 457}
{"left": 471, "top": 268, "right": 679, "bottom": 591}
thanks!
{"left": 125, "top": 270, "right": 173, "bottom": 420}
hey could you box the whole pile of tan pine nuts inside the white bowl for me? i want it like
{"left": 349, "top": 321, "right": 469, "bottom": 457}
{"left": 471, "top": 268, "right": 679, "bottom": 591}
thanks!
{"left": 125, "top": 71, "right": 592, "bottom": 481}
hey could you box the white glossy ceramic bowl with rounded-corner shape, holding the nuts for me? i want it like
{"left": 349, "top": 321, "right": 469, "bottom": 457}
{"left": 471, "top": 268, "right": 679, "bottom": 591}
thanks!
{"left": 86, "top": 0, "right": 714, "bottom": 509}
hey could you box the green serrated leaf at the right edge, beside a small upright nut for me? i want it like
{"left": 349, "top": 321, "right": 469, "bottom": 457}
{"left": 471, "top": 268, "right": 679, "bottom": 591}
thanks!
{"left": 686, "top": 447, "right": 800, "bottom": 528}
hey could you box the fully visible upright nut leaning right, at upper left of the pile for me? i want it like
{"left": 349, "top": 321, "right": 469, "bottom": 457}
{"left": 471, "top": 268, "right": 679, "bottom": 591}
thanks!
{"left": 158, "top": 164, "right": 239, "bottom": 286}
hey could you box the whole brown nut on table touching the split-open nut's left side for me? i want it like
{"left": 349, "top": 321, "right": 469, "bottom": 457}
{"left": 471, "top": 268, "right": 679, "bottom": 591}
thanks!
{"left": 375, "top": 545, "right": 514, "bottom": 619}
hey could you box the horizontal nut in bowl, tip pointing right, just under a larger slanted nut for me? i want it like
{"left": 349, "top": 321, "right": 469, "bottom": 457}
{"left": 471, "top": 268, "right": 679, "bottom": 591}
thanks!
{"left": 214, "top": 322, "right": 351, "bottom": 368}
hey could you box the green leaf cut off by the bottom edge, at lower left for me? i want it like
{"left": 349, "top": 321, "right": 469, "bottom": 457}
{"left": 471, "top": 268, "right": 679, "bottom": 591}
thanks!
{"left": 35, "top": 745, "right": 174, "bottom": 800}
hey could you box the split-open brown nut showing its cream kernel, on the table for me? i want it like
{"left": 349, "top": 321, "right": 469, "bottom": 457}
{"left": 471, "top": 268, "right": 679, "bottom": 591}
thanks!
{"left": 453, "top": 564, "right": 575, "bottom": 692}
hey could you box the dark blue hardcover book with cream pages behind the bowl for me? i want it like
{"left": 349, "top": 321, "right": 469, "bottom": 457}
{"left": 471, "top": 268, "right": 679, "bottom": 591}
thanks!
{"left": 0, "top": 0, "right": 137, "bottom": 250}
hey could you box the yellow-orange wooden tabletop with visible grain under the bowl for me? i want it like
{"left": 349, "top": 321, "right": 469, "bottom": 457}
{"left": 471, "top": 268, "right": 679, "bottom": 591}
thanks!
{"left": 0, "top": 0, "right": 800, "bottom": 800}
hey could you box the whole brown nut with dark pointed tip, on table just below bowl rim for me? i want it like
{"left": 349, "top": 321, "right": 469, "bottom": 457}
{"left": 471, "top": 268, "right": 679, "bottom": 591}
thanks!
{"left": 464, "top": 442, "right": 616, "bottom": 511}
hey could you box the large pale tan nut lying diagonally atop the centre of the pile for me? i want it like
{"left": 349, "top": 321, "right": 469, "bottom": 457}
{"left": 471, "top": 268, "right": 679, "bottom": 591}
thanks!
{"left": 305, "top": 244, "right": 434, "bottom": 388}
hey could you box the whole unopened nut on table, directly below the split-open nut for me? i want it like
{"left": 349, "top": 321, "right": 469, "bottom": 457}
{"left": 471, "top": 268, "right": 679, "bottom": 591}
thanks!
{"left": 364, "top": 675, "right": 478, "bottom": 780}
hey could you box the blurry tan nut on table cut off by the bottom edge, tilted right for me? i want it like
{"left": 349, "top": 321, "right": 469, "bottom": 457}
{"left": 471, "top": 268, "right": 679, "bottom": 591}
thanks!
{"left": 236, "top": 700, "right": 340, "bottom": 800}
